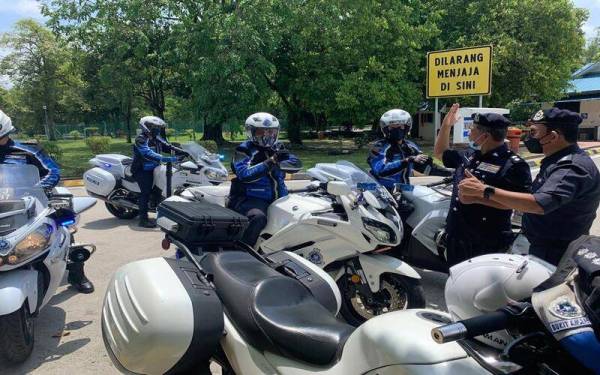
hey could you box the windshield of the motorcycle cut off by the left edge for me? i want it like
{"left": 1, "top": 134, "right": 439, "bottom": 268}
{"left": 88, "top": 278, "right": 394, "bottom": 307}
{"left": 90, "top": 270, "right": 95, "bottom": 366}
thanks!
{"left": 0, "top": 164, "right": 48, "bottom": 207}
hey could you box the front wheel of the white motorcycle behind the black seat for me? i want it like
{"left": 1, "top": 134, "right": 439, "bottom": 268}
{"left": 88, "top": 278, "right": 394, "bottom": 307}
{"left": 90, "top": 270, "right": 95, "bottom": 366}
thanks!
{"left": 338, "top": 274, "right": 425, "bottom": 327}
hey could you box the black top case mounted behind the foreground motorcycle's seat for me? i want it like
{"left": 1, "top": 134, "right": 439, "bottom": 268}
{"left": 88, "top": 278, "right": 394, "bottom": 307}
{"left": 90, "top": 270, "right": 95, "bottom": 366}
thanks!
{"left": 158, "top": 201, "right": 248, "bottom": 244}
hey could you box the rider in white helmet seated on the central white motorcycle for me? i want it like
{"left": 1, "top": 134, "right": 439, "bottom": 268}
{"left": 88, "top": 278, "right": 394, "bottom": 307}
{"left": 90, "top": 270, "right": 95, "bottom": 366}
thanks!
{"left": 229, "top": 112, "right": 301, "bottom": 246}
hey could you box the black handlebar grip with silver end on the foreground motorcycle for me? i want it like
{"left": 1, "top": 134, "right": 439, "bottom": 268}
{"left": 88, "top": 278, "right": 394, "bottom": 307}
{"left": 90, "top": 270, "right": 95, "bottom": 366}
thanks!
{"left": 431, "top": 310, "right": 511, "bottom": 344}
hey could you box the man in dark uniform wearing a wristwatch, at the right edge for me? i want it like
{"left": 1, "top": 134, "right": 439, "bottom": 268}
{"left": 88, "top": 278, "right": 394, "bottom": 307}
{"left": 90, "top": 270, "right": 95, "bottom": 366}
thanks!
{"left": 460, "top": 108, "right": 600, "bottom": 264}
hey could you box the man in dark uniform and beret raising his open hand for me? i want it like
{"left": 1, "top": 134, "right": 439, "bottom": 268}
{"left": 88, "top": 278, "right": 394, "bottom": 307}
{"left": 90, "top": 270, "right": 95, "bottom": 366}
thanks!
{"left": 434, "top": 104, "right": 531, "bottom": 266}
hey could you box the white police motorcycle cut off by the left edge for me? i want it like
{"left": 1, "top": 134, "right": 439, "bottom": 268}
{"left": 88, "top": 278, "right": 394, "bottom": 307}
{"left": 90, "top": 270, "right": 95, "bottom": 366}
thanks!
{"left": 0, "top": 164, "right": 96, "bottom": 363}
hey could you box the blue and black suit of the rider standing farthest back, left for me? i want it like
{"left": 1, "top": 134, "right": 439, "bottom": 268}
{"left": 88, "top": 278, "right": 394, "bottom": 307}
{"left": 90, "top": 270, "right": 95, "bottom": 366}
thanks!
{"left": 131, "top": 133, "right": 180, "bottom": 219}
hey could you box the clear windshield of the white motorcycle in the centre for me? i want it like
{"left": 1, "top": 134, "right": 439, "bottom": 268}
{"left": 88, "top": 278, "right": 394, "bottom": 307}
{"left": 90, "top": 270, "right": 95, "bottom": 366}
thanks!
{"left": 314, "top": 160, "right": 392, "bottom": 200}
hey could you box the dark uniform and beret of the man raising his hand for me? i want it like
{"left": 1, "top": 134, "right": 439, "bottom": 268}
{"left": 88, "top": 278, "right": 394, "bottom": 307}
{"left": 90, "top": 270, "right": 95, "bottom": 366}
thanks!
{"left": 443, "top": 114, "right": 531, "bottom": 266}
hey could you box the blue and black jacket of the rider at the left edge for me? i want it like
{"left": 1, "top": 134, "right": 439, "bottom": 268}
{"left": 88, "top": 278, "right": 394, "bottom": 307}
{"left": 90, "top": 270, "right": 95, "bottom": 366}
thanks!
{"left": 0, "top": 139, "right": 60, "bottom": 190}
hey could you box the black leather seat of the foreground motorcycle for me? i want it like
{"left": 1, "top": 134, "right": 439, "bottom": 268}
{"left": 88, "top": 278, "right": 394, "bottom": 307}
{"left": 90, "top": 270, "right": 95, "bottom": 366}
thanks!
{"left": 204, "top": 251, "right": 354, "bottom": 365}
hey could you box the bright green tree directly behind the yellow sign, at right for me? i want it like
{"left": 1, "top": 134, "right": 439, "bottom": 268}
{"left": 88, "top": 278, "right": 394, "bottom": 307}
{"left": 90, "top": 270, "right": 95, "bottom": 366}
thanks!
{"left": 430, "top": 0, "right": 587, "bottom": 106}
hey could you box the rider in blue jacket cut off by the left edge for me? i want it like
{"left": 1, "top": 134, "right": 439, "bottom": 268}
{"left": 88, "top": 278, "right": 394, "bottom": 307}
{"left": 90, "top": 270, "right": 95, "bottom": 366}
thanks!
{"left": 0, "top": 110, "right": 94, "bottom": 293}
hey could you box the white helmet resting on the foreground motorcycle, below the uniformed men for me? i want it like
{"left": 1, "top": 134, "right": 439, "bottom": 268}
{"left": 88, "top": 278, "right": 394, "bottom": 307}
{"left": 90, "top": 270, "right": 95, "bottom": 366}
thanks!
{"left": 444, "top": 254, "right": 552, "bottom": 349}
